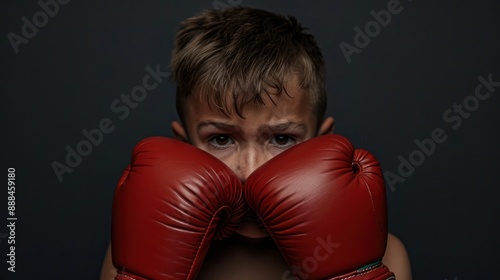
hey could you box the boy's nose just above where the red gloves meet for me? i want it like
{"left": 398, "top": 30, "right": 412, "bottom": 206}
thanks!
{"left": 234, "top": 146, "right": 272, "bottom": 183}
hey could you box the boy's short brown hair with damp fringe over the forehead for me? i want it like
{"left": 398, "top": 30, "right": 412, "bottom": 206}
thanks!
{"left": 171, "top": 7, "right": 326, "bottom": 125}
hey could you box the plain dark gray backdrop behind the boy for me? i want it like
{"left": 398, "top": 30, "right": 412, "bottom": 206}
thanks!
{"left": 0, "top": 0, "right": 500, "bottom": 280}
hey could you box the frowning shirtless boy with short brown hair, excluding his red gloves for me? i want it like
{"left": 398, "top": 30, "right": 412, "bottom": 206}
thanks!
{"left": 101, "top": 8, "right": 411, "bottom": 280}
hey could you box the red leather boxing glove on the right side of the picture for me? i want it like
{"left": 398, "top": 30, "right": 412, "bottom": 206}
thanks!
{"left": 245, "top": 134, "right": 395, "bottom": 279}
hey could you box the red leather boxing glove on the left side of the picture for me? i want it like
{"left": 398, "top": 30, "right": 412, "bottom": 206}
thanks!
{"left": 111, "top": 137, "right": 246, "bottom": 280}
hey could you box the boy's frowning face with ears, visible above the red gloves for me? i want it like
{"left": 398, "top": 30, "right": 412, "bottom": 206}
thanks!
{"left": 172, "top": 75, "right": 333, "bottom": 182}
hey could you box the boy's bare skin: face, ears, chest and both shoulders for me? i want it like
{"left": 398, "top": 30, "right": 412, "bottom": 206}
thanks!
{"left": 101, "top": 78, "right": 411, "bottom": 280}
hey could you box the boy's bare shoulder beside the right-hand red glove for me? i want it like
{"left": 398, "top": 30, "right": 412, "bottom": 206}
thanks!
{"left": 382, "top": 233, "right": 412, "bottom": 280}
